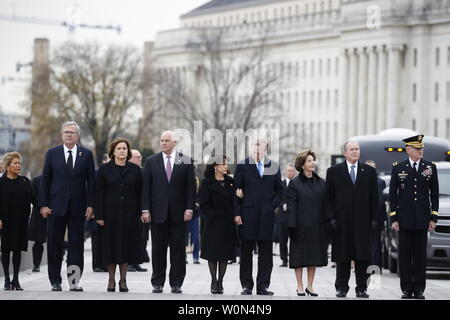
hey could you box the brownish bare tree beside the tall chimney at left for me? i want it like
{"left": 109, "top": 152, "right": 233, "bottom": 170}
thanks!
{"left": 50, "top": 42, "right": 144, "bottom": 163}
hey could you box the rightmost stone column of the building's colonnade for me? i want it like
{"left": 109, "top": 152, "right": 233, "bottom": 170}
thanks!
{"left": 386, "top": 44, "right": 403, "bottom": 128}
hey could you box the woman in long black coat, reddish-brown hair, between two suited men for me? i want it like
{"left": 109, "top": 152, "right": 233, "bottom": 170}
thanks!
{"left": 94, "top": 138, "right": 142, "bottom": 292}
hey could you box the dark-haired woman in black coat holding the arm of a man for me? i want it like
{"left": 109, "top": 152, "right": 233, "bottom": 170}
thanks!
{"left": 199, "top": 156, "right": 237, "bottom": 294}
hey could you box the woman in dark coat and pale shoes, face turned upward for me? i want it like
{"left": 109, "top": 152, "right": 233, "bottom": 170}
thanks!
{"left": 287, "top": 150, "right": 328, "bottom": 296}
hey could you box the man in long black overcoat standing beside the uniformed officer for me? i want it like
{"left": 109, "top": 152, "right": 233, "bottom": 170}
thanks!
{"left": 326, "top": 142, "right": 378, "bottom": 298}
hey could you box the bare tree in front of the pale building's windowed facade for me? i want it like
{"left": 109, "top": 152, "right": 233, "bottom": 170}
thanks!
{"left": 155, "top": 28, "right": 283, "bottom": 158}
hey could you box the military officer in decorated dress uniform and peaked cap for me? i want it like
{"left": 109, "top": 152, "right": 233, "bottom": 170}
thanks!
{"left": 389, "top": 135, "right": 439, "bottom": 299}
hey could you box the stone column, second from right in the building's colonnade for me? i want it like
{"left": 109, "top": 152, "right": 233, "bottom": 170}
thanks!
{"left": 376, "top": 45, "right": 387, "bottom": 132}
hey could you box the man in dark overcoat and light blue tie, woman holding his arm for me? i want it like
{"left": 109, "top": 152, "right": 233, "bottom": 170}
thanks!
{"left": 235, "top": 139, "right": 283, "bottom": 295}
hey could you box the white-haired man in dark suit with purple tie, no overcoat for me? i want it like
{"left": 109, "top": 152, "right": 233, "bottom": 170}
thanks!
{"left": 142, "top": 131, "right": 195, "bottom": 293}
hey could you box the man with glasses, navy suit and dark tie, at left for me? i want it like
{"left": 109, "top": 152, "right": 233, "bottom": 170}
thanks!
{"left": 39, "top": 121, "right": 95, "bottom": 291}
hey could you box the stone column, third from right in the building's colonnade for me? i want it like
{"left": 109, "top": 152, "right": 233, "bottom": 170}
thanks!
{"left": 366, "top": 47, "right": 377, "bottom": 134}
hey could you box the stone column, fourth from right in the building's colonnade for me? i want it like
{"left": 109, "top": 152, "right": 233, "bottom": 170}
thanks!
{"left": 356, "top": 48, "right": 367, "bottom": 135}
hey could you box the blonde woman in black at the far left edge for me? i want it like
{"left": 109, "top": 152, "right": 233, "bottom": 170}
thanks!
{"left": 0, "top": 152, "right": 37, "bottom": 290}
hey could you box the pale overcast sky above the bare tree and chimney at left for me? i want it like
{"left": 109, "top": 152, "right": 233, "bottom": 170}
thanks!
{"left": 0, "top": 0, "right": 208, "bottom": 113}
